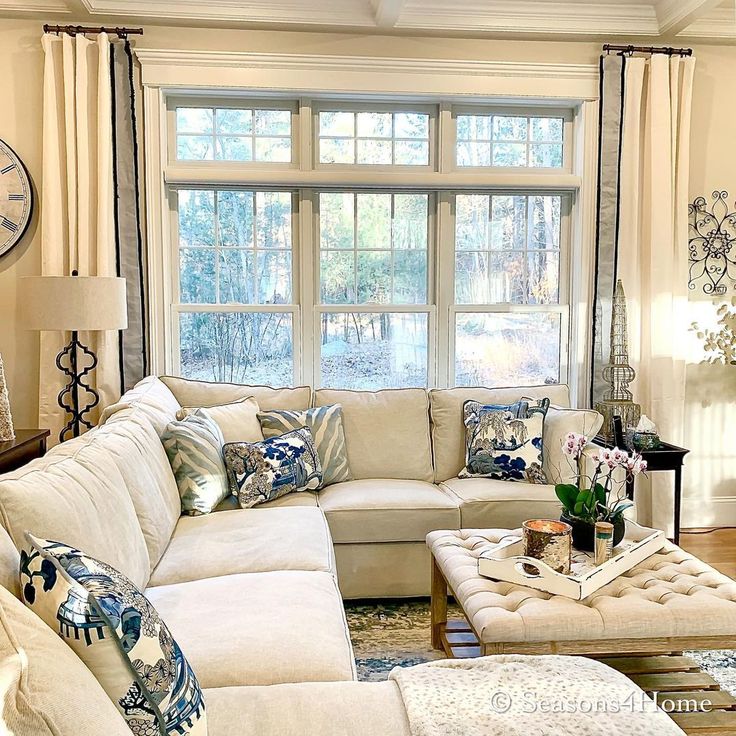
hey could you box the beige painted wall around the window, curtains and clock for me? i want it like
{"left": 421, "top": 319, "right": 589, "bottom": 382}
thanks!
{"left": 0, "top": 20, "right": 736, "bottom": 524}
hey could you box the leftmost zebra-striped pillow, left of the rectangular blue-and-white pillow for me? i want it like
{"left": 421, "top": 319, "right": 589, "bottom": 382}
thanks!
{"left": 161, "top": 409, "right": 231, "bottom": 516}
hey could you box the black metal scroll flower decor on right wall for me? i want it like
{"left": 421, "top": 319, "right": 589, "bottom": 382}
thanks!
{"left": 688, "top": 191, "right": 736, "bottom": 296}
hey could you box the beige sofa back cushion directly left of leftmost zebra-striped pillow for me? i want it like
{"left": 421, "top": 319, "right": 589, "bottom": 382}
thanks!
{"left": 86, "top": 409, "right": 181, "bottom": 572}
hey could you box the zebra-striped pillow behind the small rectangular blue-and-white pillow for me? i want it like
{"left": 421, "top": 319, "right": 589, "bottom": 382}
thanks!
{"left": 258, "top": 404, "right": 353, "bottom": 488}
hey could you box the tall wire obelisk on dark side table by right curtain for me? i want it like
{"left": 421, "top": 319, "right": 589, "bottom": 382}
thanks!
{"left": 595, "top": 279, "right": 641, "bottom": 442}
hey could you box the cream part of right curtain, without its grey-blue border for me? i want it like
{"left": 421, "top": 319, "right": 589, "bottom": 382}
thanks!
{"left": 617, "top": 54, "right": 695, "bottom": 533}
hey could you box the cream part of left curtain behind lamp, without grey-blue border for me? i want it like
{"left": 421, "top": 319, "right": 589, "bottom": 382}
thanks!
{"left": 39, "top": 34, "right": 120, "bottom": 438}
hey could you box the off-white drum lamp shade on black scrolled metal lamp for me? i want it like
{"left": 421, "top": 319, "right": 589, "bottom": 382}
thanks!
{"left": 19, "top": 276, "right": 128, "bottom": 332}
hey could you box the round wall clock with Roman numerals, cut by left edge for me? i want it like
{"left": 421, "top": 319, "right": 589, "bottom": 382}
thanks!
{"left": 0, "top": 140, "right": 33, "bottom": 256}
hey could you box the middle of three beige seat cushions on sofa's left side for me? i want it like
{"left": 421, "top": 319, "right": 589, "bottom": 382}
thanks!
{"left": 146, "top": 572, "right": 355, "bottom": 688}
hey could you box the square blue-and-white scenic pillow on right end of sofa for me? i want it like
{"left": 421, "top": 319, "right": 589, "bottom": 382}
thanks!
{"left": 460, "top": 399, "right": 549, "bottom": 483}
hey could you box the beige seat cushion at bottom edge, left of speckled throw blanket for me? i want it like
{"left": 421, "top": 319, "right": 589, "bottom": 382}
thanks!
{"left": 205, "top": 682, "right": 411, "bottom": 736}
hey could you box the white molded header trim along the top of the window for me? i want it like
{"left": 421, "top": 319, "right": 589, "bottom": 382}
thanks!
{"left": 136, "top": 48, "right": 598, "bottom": 100}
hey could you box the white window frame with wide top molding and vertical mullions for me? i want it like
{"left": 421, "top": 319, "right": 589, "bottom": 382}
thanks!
{"left": 138, "top": 50, "right": 597, "bottom": 402}
